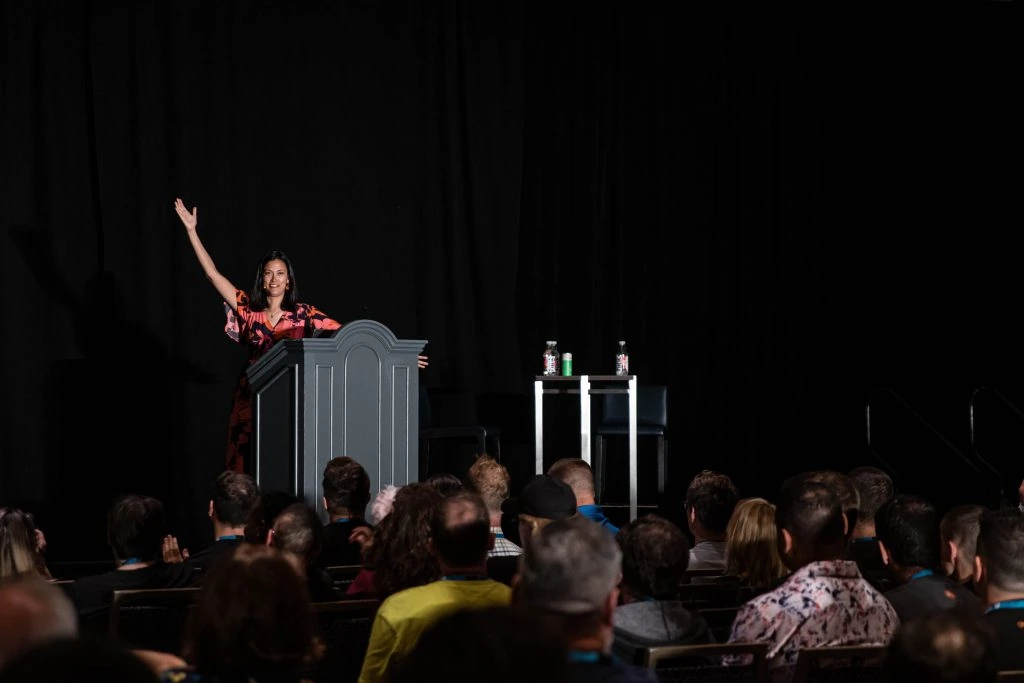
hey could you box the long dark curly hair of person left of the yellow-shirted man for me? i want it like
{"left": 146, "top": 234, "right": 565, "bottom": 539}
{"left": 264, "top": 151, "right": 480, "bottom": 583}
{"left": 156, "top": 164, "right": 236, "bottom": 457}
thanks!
{"left": 366, "top": 482, "right": 444, "bottom": 600}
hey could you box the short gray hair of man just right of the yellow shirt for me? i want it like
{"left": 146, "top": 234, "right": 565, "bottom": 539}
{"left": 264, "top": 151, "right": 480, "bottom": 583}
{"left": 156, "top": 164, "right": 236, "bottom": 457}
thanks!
{"left": 518, "top": 515, "right": 623, "bottom": 614}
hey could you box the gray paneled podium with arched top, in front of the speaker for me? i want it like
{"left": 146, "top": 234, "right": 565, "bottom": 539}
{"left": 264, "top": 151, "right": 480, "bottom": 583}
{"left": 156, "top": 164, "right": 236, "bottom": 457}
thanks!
{"left": 248, "top": 321, "right": 427, "bottom": 515}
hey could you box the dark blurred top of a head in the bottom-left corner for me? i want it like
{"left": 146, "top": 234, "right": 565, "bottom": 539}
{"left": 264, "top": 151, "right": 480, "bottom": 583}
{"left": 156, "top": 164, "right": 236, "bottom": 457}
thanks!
{"left": 0, "top": 639, "right": 160, "bottom": 683}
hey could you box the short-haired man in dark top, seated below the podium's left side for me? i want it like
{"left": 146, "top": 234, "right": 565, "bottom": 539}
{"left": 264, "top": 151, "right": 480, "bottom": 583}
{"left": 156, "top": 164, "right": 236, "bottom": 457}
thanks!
{"left": 267, "top": 503, "right": 344, "bottom": 602}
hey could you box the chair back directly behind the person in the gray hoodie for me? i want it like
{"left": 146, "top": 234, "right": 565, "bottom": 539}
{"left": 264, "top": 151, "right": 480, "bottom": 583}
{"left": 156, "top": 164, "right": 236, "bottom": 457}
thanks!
{"left": 641, "top": 643, "right": 768, "bottom": 683}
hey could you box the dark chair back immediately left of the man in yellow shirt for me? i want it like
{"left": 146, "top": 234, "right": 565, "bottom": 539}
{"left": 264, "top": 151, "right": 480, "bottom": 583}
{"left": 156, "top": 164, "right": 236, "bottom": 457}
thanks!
{"left": 312, "top": 600, "right": 380, "bottom": 683}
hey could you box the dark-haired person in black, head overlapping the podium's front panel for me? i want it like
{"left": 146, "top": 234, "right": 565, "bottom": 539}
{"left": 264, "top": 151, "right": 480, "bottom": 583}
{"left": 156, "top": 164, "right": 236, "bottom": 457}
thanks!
{"left": 319, "top": 456, "right": 370, "bottom": 566}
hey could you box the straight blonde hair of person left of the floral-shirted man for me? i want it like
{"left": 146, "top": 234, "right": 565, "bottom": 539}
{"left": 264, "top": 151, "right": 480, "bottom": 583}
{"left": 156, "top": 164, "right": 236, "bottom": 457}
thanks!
{"left": 725, "top": 498, "right": 787, "bottom": 588}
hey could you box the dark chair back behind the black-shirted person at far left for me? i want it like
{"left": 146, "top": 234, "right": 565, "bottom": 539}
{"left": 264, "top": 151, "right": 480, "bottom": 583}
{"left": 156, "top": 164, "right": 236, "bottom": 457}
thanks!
{"left": 110, "top": 588, "right": 199, "bottom": 654}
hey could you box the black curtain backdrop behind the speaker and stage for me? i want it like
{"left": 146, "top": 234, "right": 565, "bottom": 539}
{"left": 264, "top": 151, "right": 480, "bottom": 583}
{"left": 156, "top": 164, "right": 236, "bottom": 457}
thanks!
{"left": 0, "top": 0, "right": 1024, "bottom": 557}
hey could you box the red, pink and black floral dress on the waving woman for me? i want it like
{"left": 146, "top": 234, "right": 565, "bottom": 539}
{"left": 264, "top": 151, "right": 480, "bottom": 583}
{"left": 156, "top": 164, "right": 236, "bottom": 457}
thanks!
{"left": 224, "top": 290, "right": 341, "bottom": 472}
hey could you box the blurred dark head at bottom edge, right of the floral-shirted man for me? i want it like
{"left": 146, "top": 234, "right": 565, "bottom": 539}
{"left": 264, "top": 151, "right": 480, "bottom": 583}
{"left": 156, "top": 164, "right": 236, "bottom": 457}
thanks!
{"left": 883, "top": 610, "right": 996, "bottom": 683}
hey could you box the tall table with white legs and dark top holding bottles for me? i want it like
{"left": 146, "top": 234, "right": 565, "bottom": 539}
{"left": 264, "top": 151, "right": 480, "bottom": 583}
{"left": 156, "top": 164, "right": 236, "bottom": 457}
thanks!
{"left": 534, "top": 375, "right": 637, "bottom": 520}
